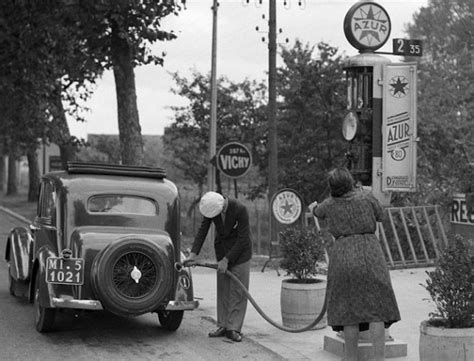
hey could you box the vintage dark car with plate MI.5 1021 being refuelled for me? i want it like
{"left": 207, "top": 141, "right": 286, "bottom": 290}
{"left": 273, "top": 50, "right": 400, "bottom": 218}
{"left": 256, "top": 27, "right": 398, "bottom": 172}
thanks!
{"left": 5, "top": 162, "right": 198, "bottom": 332}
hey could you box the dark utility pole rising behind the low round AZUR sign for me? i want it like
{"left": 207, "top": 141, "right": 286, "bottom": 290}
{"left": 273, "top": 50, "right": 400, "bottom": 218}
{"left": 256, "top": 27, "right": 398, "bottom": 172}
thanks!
{"left": 268, "top": 0, "right": 278, "bottom": 242}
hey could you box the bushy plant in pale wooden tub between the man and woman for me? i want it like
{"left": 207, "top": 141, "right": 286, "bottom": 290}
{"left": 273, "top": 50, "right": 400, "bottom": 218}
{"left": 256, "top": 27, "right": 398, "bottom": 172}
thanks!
{"left": 279, "top": 227, "right": 327, "bottom": 328}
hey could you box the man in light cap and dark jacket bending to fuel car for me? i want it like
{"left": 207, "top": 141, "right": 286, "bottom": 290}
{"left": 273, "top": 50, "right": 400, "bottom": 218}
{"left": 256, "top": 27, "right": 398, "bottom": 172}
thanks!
{"left": 186, "top": 192, "right": 252, "bottom": 342}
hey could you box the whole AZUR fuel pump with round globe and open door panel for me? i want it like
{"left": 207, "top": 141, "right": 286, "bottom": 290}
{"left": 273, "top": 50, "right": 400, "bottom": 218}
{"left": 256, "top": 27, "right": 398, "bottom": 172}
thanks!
{"left": 342, "top": 1, "right": 414, "bottom": 206}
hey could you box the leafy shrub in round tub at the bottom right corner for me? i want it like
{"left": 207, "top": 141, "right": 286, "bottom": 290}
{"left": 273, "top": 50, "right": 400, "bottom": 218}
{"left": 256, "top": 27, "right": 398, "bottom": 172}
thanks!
{"left": 419, "top": 235, "right": 474, "bottom": 361}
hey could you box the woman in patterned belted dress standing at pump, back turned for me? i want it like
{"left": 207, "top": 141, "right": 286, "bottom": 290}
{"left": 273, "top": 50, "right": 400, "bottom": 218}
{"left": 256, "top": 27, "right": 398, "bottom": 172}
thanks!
{"left": 310, "top": 168, "right": 400, "bottom": 361}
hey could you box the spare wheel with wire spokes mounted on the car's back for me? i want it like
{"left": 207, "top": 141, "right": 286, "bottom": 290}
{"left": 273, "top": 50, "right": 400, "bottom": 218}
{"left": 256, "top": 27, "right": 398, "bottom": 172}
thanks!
{"left": 92, "top": 239, "right": 173, "bottom": 316}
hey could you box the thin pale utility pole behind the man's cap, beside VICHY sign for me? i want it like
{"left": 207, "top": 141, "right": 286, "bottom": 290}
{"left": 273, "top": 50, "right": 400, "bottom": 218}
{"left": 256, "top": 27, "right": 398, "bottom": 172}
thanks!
{"left": 207, "top": 0, "right": 219, "bottom": 191}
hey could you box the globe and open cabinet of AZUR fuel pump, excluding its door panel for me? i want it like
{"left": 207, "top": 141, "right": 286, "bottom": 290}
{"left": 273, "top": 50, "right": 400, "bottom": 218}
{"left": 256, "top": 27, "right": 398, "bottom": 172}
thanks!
{"left": 342, "top": 2, "right": 391, "bottom": 205}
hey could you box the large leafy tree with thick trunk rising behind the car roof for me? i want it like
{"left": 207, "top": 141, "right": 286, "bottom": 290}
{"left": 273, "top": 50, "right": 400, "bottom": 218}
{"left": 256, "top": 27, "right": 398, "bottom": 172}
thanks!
{"left": 71, "top": 0, "right": 184, "bottom": 164}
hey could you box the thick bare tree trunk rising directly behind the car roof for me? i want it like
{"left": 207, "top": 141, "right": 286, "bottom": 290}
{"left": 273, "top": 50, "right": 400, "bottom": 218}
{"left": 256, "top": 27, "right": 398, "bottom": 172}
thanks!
{"left": 111, "top": 16, "right": 144, "bottom": 165}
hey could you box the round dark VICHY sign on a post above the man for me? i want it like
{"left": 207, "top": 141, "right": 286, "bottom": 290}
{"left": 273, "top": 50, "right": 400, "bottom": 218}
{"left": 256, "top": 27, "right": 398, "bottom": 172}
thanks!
{"left": 217, "top": 142, "right": 252, "bottom": 178}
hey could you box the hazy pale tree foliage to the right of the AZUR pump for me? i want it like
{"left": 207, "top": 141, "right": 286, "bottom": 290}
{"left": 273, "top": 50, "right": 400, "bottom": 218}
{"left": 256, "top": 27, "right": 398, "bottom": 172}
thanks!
{"left": 407, "top": 0, "right": 474, "bottom": 204}
